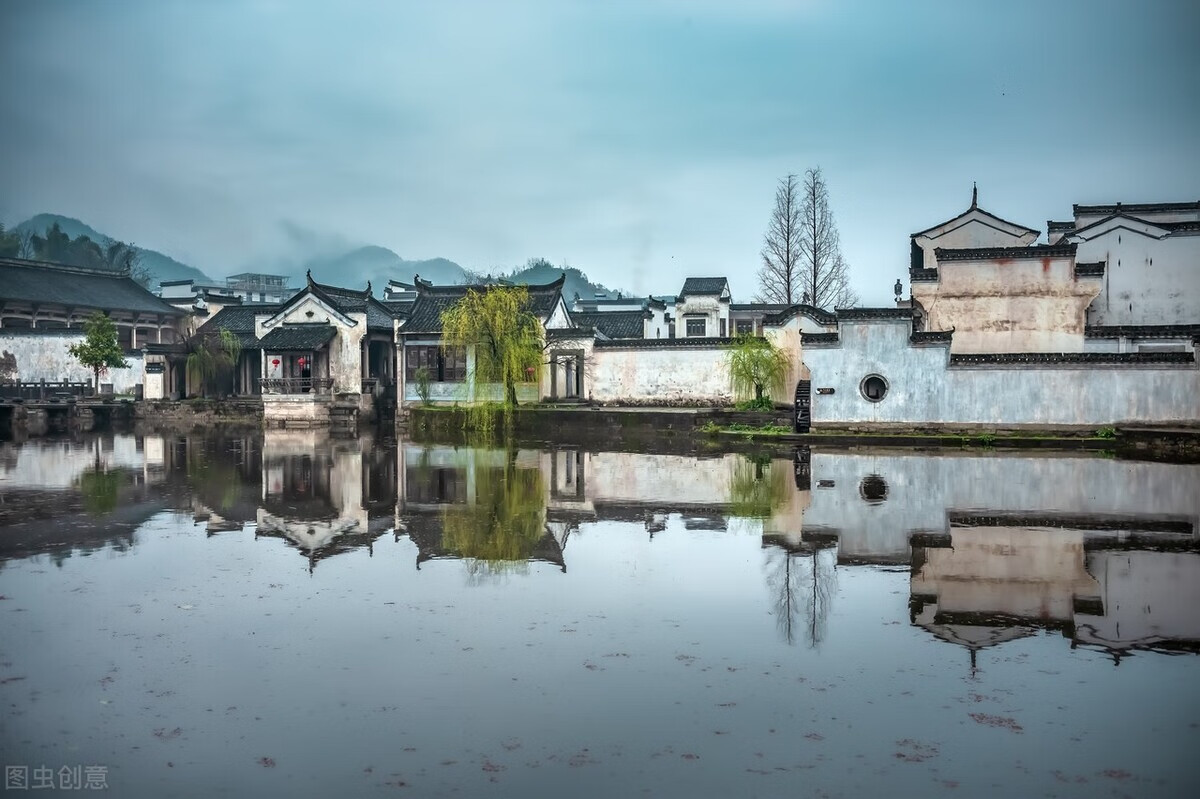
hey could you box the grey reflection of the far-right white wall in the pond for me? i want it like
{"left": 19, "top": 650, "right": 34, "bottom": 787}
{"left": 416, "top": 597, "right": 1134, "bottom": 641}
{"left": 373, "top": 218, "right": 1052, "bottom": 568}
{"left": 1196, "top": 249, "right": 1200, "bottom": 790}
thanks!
{"left": 1075, "top": 551, "right": 1200, "bottom": 647}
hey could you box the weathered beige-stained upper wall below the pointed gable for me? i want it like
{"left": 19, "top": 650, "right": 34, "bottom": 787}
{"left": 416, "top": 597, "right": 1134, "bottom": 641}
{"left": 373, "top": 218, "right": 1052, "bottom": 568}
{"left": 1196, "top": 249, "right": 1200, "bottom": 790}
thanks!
{"left": 912, "top": 257, "right": 1100, "bottom": 353}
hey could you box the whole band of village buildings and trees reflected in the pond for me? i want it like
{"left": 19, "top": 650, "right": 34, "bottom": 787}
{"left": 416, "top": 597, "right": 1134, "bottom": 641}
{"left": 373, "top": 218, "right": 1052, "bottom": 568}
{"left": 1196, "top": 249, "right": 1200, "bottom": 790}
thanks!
{"left": 0, "top": 431, "right": 1200, "bottom": 666}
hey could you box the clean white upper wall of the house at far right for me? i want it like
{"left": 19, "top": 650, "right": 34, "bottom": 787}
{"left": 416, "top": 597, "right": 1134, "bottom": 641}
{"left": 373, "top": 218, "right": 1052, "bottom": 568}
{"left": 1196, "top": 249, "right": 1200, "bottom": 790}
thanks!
{"left": 1075, "top": 228, "right": 1200, "bottom": 325}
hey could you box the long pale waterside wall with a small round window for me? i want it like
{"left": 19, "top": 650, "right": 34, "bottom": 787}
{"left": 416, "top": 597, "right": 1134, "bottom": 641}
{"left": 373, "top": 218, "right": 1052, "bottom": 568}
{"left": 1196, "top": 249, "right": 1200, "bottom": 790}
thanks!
{"left": 804, "top": 320, "right": 1200, "bottom": 426}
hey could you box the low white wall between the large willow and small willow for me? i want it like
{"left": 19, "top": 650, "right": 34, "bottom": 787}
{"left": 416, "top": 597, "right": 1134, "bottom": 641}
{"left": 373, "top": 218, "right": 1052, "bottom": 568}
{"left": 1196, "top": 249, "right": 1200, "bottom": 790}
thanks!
{"left": 584, "top": 347, "right": 733, "bottom": 405}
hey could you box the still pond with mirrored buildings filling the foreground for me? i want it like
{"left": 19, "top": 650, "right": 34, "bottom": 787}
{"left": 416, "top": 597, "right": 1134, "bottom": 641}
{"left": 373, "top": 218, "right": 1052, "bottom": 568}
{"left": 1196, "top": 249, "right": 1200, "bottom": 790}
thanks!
{"left": 0, "top": 432, "right": 1200, "bottom": 797}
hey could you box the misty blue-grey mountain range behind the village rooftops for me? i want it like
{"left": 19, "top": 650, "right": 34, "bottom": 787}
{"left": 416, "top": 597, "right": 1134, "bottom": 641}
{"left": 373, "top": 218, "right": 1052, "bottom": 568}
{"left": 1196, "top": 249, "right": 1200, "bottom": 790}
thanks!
{"left": 13, "top": 214, "right": 617, "bottom": 301}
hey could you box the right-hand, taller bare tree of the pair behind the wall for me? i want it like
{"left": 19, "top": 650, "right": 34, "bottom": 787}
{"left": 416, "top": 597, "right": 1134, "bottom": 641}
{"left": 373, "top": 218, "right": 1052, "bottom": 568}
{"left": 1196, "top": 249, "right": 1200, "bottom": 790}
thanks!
{"left": 798, "top": 167, "right": 858, "bottom": 310}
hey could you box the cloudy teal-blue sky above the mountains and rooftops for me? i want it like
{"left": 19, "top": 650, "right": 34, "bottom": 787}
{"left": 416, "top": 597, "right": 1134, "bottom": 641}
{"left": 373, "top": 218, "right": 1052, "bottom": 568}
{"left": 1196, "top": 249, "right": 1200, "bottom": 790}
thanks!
{"left": 0, "top": 0, "right": 1200, "bottom": 305}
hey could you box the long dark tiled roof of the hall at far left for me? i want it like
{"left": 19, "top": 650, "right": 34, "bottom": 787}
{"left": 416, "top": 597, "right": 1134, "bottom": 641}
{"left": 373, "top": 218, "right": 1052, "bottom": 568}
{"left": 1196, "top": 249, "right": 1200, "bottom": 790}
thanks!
{"left": 0, "top": 258, "right": 185, "bottom": 317}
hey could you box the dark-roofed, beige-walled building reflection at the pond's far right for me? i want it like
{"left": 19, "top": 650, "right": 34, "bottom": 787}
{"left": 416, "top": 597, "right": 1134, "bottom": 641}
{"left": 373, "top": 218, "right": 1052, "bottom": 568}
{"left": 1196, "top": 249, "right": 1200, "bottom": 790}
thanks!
{"left": 910, "top": 517, "right": 1200, "bottom": 663}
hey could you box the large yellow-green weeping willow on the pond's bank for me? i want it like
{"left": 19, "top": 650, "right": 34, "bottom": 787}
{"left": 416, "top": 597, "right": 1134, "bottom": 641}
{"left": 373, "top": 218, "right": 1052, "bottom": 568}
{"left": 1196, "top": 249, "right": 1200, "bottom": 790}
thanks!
{"left": 442, "top": 286, "right": 542, "bottom": 410}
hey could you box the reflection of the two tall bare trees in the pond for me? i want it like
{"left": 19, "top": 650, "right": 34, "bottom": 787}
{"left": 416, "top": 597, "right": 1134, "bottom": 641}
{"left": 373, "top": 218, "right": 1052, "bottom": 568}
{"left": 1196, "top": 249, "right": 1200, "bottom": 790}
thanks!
{"left": 767, "top": 537, "right": 838, "bottom": 647}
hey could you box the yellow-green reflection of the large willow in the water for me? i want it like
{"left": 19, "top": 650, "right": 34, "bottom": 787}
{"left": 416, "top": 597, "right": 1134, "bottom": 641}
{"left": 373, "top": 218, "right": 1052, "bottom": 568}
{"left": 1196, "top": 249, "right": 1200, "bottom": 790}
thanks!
{"left": 442, "top": 452, "right": 546, "bottom": 576}
